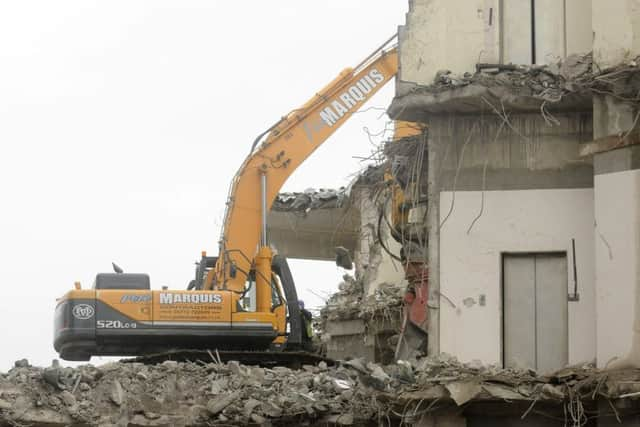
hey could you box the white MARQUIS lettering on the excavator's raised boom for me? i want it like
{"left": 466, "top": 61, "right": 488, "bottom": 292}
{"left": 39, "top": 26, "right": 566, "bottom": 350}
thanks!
{"left": 303, "top": 68, "right": 384, "bottom": 142}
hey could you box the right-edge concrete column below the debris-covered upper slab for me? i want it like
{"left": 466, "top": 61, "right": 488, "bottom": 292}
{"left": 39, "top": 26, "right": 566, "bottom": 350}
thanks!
{"left": 593, "top": 96, "right": 640, "bottom": 367}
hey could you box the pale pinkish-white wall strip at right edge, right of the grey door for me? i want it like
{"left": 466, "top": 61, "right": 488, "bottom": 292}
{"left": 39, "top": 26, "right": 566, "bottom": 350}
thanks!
{"left": 594, "top": 170, "right": 640, "bottom": 367}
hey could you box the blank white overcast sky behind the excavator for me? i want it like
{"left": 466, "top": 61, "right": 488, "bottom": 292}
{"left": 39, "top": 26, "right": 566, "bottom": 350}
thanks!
{"left": 0, "top": 0, "right": 407, "bottom": 371}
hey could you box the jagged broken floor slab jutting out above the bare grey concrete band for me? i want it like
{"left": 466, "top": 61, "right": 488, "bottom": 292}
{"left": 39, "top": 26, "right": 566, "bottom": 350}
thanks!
{"left": 389, "top": 54, "right": 637, "bottom": 121}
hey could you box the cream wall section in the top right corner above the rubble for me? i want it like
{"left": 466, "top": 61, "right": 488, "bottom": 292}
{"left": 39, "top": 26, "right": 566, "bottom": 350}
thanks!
{"left": 592, "top": 0, "right": 640, "bottom": 68}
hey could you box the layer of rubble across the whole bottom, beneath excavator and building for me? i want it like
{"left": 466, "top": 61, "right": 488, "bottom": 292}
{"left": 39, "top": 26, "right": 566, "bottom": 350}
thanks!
{"left": 0, "top": 355, "right": 640, "bottom": 426}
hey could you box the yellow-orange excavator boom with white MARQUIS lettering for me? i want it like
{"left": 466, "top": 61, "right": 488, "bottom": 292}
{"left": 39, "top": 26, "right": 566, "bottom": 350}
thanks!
{"left": 204, "top": 36, "right": 398, "bottom": 296}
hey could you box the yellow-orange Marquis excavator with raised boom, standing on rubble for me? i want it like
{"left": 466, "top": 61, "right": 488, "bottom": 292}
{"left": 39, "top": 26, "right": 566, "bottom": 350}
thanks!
{"left": 54, "top": 36, "right": 398, "bottom": 360}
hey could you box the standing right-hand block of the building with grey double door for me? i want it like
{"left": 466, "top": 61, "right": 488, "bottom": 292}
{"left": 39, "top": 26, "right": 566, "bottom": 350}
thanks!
{"left": 389, "top": 0, "right": 640, "bottom": 372}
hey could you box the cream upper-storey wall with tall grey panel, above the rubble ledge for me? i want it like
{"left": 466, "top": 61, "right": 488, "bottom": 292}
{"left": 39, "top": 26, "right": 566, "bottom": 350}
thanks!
{"left": 399, "top": 0, "right": 592, "bottom": 85}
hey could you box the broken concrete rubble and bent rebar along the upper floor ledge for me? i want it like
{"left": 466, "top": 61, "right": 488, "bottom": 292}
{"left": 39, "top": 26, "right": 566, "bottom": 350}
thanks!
{"left": 396, "top": 53, "right": 640, "bottom": 113}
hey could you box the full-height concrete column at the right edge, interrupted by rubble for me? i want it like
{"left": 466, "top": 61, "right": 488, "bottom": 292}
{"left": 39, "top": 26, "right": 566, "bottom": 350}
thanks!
{"left": 592, "top": 0, "right": 640, "bottom": 367}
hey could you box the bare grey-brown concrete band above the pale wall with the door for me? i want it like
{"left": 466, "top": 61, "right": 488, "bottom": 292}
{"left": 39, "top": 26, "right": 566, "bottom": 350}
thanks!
{"left": 429, "top": 113, "right": 593, "bottom": 190}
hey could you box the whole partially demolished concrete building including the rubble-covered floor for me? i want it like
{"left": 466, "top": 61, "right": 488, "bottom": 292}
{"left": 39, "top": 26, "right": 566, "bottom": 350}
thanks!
{"left": 6, "top": 0, "right": 640, "bottom": 427}
